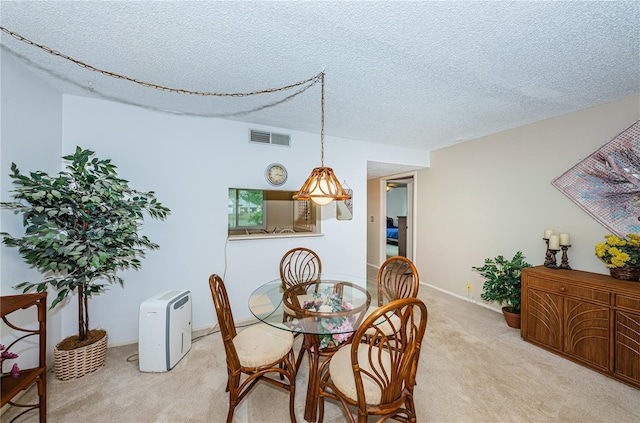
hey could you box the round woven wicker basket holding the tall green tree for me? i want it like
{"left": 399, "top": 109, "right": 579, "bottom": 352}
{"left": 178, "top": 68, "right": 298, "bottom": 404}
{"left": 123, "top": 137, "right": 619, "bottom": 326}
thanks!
{"left": 53, "top": 333, "right": 107, "bottom": 380}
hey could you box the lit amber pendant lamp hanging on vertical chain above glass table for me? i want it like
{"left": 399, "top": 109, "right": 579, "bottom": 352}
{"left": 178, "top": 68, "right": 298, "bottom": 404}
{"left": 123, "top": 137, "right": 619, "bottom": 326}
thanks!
{"left": 293, "top": 71, "right": 351, "bottom": 206}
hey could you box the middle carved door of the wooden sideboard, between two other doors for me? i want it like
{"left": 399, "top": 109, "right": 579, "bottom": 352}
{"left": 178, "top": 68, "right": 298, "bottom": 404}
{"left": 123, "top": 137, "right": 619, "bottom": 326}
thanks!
{"left": 564, "top": 299, "right": 609, "bottom": 370}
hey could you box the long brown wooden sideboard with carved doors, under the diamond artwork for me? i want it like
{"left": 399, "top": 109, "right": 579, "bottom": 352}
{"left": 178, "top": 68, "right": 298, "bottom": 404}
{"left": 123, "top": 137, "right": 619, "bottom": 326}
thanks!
{"left": 520, "top": 266, "right": 640, "bottom": 388}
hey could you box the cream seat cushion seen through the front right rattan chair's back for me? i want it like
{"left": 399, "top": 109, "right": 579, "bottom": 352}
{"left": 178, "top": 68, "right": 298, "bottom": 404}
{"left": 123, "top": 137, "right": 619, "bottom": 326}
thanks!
{"left": 329, "top": 344, "right": 391, "bottom": 405}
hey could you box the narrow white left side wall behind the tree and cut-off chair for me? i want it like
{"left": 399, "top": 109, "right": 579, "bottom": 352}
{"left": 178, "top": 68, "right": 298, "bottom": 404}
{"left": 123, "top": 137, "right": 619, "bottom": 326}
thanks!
{"left": 0, "top": 50, "right": 62, "bottom": 368}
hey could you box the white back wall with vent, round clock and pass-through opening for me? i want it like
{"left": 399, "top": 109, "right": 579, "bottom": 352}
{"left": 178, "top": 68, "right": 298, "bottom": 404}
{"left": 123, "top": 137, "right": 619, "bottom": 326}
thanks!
{"left": 53, "top": 96, "right": 428, "bottom": 343}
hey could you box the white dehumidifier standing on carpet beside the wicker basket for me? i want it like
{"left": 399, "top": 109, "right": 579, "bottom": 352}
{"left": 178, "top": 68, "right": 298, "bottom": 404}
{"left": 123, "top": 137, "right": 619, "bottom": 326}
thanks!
{"left": 138, "top": 290, "right": 191, "bottom": 372}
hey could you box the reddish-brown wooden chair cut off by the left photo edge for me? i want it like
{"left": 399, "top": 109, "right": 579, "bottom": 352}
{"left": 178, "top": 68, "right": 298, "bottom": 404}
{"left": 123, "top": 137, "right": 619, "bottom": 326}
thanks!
{"left": 0, "top": 292, "right": 47, "bottom": 423}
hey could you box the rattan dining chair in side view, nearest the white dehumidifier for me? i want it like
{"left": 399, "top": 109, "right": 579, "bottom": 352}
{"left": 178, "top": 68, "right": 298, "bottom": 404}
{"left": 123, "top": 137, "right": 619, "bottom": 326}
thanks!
{"left": 209, "top": 274, "right": 296, "bottom": 423}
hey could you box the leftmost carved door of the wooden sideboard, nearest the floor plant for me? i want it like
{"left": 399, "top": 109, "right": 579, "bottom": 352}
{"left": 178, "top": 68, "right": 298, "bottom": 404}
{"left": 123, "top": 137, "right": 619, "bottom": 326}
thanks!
{"left": 526, "top": 289, "right": 563, "bottom": 350}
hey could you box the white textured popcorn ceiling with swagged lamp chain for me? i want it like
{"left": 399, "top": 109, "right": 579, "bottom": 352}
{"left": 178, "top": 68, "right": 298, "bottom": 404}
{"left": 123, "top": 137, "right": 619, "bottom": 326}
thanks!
{"left": 0, "top": 0, "right": 640, "bottom": 164}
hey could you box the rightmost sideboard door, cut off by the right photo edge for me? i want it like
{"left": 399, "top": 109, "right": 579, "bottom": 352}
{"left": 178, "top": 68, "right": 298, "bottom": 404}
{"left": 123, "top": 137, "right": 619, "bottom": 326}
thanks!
{"left": 614, "top": 311, "right": 640, "bottom": 383}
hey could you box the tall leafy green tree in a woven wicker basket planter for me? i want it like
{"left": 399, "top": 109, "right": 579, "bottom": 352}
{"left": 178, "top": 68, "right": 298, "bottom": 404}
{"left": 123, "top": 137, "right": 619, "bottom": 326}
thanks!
{"left": 0, "top": 147, "right": 170, "bottom": 380}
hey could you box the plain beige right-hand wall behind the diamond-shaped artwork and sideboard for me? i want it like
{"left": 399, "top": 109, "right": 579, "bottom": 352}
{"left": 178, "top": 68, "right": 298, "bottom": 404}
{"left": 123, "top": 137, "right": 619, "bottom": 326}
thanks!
{"left": 415, "top": 95, "right": 640, "bottom": 310}
